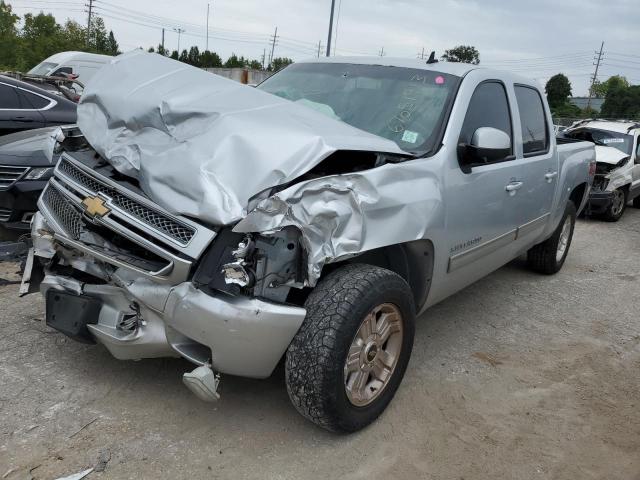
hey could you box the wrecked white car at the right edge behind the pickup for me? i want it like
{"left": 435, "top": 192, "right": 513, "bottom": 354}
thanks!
{"left": 565, "top": 120, "right": 640, "bottom": 222}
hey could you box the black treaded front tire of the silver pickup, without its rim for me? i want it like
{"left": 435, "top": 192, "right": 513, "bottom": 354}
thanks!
{"left": 285, "top": 264, "right": 415, "bottom": 432}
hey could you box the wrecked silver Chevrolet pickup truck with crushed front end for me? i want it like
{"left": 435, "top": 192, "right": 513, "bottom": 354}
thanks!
{"left": 22, "top": 52, "right": 595, "bottom": 432}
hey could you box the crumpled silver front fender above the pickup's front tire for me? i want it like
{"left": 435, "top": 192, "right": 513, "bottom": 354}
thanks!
{"left": 233, "top": 159, "right": 444, "bottom": 286}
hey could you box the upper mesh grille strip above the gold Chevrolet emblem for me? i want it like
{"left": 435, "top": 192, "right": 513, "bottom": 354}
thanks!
{"left": 58, "top": 159, "right": 195, "bottom": 245}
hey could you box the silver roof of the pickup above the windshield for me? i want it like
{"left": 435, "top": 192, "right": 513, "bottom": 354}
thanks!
{"left": 297, "top": 56, "right": 539, "bottom": 86}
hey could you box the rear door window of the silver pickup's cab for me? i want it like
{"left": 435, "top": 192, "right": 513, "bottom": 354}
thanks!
{"left": 515, "top": 85, "right": 549, "bottom": 156}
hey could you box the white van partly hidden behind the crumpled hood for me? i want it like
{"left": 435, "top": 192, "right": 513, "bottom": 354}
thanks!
{"left": 28, "top": 52, "right": 113, "bottom": 83}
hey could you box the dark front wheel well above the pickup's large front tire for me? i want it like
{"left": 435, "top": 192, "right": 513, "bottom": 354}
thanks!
{"left": 330, "top": 240, "right": 433, "bottom": 310}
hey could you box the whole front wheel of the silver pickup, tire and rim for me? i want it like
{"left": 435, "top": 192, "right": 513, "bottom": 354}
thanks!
{"left": 286, "top": 264, "right": 415, "bottom": 432}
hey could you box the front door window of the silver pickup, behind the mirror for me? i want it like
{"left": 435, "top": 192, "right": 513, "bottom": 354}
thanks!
{"left": 459, "top": 81, "right": 513, "bottom": 153}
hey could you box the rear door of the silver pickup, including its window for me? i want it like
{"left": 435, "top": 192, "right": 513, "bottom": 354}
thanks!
{"left": 511, "top": 84, "right": 559, "bottom": 250}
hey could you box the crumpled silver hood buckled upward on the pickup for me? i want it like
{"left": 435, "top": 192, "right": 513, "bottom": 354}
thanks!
{"left": 78, "top": 51, "right": 406, "bottom": 225}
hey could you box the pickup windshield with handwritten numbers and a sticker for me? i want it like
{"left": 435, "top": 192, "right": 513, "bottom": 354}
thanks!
{"left": 258, "top": 63, "right": 460, "bottom": 154}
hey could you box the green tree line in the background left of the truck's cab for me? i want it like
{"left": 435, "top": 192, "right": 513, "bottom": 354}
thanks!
{"left": 0, "top": 0, "right": 293, "bottom": 72}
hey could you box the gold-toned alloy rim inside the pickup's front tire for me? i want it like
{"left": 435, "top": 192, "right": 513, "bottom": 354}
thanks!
{"left": 344, "top": 303, "right": 403, "bottom": 407}
